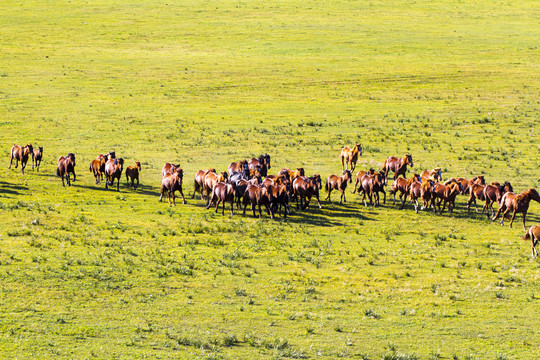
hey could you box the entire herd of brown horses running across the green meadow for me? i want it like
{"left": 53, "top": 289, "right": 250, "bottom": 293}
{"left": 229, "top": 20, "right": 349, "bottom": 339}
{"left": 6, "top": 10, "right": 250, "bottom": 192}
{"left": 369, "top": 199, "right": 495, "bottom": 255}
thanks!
{"left": 8, "top": 144, "right": 540, "bottom": 257}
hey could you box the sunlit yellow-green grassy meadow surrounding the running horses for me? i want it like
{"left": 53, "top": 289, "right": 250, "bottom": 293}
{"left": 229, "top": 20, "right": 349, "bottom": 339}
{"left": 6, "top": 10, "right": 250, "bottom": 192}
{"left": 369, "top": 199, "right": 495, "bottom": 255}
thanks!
{"left": 0, "top": 0, "right": 540, "bottom": 360}
